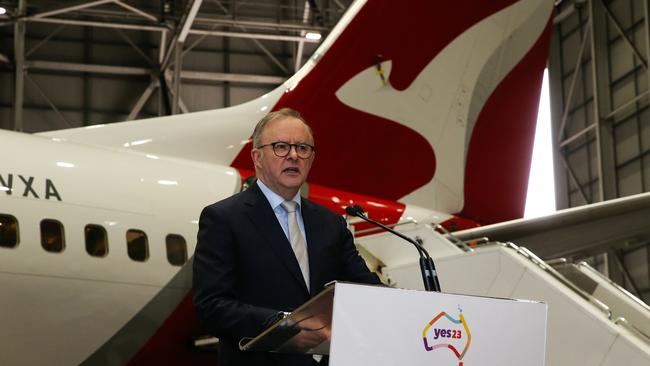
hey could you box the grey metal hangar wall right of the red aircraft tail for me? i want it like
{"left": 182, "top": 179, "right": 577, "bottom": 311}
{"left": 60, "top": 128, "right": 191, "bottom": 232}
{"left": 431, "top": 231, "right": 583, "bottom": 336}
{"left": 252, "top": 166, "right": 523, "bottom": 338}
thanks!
{"left": 549, "top": 0, "right": 650, "bottom": 303}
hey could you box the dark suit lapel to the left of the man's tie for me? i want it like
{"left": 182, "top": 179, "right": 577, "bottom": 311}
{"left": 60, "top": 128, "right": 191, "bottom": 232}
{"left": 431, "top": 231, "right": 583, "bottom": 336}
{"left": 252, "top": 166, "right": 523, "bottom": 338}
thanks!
{"left": 245, "top": 183, "right": 311, "bottom": 292}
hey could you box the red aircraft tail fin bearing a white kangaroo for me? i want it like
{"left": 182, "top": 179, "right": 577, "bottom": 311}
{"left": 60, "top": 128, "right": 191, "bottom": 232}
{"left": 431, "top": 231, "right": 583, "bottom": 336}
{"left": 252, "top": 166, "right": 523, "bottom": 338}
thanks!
{"left": 232, "top": 0, "right": 553, "bottom": 223}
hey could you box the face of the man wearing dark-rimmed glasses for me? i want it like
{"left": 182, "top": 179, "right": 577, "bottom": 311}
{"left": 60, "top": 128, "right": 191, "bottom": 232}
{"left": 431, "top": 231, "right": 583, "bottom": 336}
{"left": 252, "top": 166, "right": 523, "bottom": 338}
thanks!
{"left": 251, "top": 117, "right": 315, "bottom": 200}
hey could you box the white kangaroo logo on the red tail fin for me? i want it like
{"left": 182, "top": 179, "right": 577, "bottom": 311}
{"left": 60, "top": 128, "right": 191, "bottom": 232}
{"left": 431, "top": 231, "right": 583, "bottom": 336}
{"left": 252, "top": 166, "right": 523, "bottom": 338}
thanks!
{"left": 336, "top": 0, "right": 553, "bottom": 213}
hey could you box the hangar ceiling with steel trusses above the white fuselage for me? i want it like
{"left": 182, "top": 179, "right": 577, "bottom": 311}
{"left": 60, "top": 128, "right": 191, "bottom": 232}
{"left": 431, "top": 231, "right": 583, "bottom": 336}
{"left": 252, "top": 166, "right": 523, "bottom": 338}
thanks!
{"left": 0, "top": 0, "right": 351, "bottom": 132}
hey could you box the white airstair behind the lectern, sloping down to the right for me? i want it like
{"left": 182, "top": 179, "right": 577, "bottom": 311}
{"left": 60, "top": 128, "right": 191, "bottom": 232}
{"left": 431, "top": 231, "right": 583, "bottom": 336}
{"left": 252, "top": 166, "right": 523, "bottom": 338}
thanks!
{"left": 356, "top": 223, "right": 650, "bottom": 366}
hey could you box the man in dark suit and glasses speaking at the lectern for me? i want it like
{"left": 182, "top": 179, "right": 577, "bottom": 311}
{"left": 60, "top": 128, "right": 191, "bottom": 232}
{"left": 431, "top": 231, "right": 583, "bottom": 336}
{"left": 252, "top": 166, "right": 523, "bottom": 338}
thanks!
{"left": 193, "top": 109, "right": 380, "bottom": 366}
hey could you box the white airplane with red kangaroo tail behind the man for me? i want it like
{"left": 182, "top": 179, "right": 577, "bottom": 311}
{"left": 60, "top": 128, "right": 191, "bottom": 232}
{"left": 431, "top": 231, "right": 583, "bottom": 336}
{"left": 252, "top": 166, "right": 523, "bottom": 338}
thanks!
{"left": 0, "top": 0, "right": 644, "bottom": 365}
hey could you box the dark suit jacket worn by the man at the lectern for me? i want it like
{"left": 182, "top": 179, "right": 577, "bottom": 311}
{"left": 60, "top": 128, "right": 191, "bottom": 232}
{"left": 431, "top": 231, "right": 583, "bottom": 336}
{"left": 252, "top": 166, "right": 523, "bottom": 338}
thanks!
{"left": 193, "top": 184, "right": 380, "bottom": 366}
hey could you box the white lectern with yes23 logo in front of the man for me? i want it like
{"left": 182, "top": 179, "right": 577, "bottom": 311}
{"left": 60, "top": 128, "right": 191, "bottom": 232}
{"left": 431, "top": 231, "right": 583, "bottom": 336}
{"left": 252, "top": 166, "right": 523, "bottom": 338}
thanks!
{"left": 241, "top": 282, "right": 547, "bottom": 366}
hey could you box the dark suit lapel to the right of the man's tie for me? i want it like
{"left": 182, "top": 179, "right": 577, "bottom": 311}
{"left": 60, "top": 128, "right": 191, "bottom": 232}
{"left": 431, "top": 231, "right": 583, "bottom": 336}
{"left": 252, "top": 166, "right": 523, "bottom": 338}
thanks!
{"left": 301, "top": 198, "right": 323, "bottom": 293}
